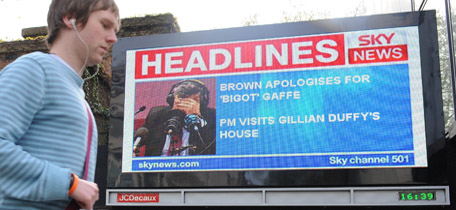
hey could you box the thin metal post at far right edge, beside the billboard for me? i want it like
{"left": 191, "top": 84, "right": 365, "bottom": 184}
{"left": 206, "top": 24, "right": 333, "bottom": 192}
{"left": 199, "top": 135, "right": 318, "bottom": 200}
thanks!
{"left": 445, "top": 0, "right": 456, "bottom": 120}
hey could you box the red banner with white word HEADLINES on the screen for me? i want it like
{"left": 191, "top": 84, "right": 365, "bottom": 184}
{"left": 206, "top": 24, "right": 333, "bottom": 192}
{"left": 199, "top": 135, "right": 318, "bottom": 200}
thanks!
{"left": 135, "top": 34, "right": 345, "bottom": 79}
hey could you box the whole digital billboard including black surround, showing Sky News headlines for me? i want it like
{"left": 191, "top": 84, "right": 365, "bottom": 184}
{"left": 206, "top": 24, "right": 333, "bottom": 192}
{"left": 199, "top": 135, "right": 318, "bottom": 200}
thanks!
{"left": 110, "top": 12, "right": 443, "bottom": 187}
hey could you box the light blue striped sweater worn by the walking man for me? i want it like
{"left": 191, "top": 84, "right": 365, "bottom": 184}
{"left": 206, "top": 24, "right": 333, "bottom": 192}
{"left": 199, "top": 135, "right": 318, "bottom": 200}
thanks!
{"left": 0, "top": 52, "right": 97, "bottom": 209}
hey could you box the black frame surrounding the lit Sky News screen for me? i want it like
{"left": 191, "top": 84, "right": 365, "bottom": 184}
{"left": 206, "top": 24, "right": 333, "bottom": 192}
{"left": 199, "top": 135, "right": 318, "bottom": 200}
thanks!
{"left": 107, "top": 11, "right": 448, "bottom": 189}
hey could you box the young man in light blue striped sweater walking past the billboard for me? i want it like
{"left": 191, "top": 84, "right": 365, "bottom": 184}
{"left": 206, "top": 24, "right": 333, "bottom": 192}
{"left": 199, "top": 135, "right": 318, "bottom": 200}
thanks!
{"left": 0, "top": 0, "right": 120, "bottom": 210}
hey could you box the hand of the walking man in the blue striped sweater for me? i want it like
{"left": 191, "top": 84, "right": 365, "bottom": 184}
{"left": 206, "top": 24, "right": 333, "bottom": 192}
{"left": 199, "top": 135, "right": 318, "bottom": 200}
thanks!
{"left": 70, "top": 179, "right": 99, "bottom": 209}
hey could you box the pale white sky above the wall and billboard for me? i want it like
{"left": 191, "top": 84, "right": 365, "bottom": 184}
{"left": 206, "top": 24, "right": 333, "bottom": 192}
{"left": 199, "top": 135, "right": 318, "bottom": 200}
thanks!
{"left": 0, "top": 0, "right": 443, "bottom": 41}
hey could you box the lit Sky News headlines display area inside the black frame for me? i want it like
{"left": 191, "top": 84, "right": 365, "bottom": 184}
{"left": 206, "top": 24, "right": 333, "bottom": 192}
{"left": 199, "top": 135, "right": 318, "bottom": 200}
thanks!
{"left": 123, "top": 26, "right": 427, "bottom": 172}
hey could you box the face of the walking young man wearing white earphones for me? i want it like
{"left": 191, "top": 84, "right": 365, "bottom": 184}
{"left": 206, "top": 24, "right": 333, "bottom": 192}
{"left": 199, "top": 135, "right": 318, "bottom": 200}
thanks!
{"left": 80, "top": 9, "right": 119, "bottom": 66}
